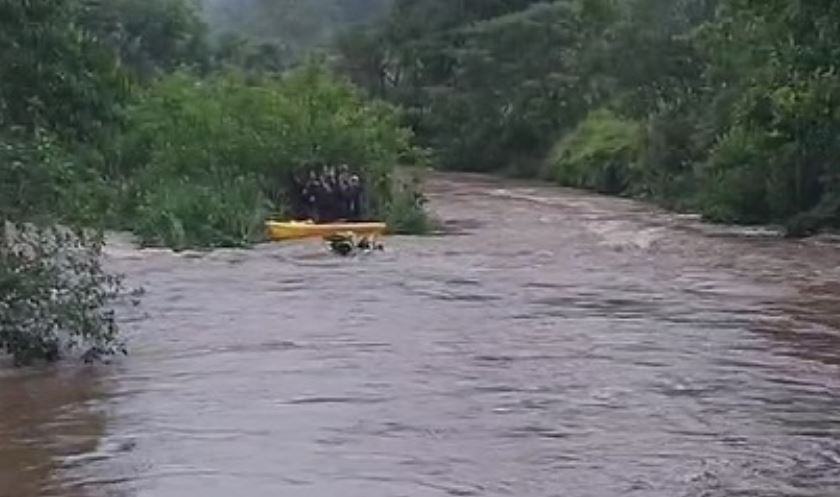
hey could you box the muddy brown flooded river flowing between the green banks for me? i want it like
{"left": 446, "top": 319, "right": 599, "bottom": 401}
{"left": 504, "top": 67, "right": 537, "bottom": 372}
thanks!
{"left": 0, "top": 171, "right": 840, "bottom": 497}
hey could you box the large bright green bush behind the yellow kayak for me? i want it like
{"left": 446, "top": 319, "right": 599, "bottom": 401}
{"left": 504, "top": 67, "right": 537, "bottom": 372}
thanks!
{"left": 119, "top": 64, "right": 420, "bottom": 248}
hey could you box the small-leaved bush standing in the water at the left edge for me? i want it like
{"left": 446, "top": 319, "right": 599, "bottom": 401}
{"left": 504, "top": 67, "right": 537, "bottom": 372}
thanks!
{"left": 0, "top": 223, "right": 123, "bottom": 365}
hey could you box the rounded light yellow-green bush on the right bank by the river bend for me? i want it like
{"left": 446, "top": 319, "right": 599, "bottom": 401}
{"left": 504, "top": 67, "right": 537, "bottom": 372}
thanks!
{"left": 545, "top": 109, "right": 641, "bottom": 194}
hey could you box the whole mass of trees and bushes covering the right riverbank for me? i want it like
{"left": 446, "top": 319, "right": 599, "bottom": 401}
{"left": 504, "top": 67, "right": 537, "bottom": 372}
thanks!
{"left": 337, "top": 0, "right": 840, "bottom": 235}
